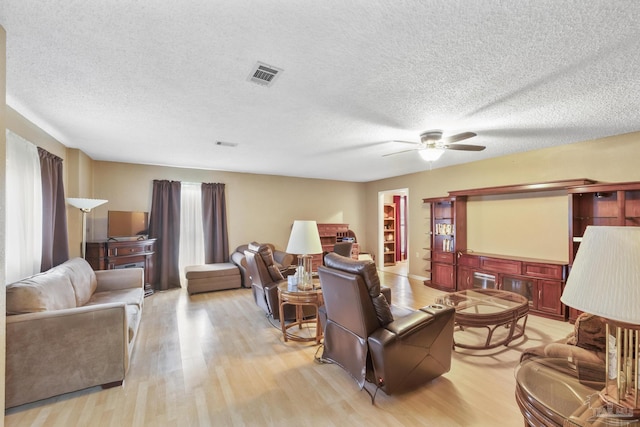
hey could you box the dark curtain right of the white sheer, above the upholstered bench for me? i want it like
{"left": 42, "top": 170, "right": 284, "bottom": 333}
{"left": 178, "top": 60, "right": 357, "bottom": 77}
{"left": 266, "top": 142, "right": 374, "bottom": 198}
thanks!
{"left": 202, "top": 183, "right": 229, "bottom": 264}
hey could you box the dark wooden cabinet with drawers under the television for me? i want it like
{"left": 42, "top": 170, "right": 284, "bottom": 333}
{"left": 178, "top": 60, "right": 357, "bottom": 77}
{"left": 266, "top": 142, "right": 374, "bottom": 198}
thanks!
{"left": 86, "top": 239, "right": 156, "bottom": 289}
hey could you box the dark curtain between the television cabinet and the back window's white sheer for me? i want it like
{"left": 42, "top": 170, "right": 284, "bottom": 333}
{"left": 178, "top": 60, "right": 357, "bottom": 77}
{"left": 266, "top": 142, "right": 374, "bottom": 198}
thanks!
{"left": 149, "top": 180, "right": 181, "bottom": 291}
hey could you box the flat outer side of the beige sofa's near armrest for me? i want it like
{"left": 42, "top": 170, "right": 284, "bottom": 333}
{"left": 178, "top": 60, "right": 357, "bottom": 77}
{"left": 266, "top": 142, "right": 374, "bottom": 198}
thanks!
{"left": 5, "top": 303, "right": 129, "bottom": 407}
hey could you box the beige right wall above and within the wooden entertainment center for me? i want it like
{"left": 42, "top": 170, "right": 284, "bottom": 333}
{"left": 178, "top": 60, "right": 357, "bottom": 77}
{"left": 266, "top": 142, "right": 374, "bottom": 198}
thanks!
{"left": 365, "top": 132, "right": 640, "bottom": 277}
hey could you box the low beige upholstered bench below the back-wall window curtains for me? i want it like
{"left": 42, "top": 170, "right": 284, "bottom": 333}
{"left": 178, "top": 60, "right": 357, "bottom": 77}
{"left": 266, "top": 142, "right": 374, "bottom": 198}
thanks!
{"left": 184, "top": 262, "right": 242, "bottom": 294}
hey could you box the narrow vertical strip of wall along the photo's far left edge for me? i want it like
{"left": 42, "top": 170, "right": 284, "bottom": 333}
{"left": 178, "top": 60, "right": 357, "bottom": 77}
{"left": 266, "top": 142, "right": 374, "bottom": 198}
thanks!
{"left": 0, "top": 22, "right": 7, "bottom": 426}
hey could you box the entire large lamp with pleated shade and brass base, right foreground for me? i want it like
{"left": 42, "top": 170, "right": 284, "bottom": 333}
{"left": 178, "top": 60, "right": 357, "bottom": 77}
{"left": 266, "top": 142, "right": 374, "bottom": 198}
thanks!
{"left": 560, "top": 226, "right": 640, "bottom": 417}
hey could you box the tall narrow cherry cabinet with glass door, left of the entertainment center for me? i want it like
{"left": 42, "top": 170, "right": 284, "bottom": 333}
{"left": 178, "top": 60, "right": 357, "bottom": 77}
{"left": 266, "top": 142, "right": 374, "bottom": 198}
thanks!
{"left": 422, "top": 196, "right": 467, "bottom": 291}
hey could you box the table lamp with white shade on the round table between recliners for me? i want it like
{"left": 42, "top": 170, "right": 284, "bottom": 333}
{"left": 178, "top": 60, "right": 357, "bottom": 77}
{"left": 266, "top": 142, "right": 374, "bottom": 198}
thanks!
{"left": 287, "top": 220, "right": 322, "bottom": 290}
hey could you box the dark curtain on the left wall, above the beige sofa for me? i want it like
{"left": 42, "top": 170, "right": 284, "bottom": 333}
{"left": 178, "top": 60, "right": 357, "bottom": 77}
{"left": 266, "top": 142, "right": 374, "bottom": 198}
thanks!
{"left": 38, "top": 147, "right": 69, "bottom": 271}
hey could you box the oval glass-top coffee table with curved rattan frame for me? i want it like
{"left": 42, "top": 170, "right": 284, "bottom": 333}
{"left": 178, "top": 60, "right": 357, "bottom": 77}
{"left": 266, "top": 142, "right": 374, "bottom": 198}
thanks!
{"left": 436, "top": 289, "right": 529, "bottom": 350}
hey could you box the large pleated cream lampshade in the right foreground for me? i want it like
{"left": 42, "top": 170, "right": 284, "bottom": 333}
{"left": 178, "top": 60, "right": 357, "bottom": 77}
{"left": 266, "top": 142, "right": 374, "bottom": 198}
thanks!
{"left": 560, "top": 226, "right": 640, "bottom": 325}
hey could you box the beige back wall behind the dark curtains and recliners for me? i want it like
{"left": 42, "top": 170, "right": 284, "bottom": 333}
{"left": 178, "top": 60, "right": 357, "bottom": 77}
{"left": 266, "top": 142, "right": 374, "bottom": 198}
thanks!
{"left": 90, "top": 162, "right": 367, "bottom": 251}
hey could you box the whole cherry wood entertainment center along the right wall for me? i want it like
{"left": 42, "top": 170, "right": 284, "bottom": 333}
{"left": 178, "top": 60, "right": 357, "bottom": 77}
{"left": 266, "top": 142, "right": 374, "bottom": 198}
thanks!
{"left": 422, "top": 179, "right": 608, "bottom": 320}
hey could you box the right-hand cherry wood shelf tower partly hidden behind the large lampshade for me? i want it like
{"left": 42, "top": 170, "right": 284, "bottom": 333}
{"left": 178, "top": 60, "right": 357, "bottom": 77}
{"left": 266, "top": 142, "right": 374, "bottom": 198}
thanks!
{"left": 568, "top": 182, "right": 640, "bottom": 321}
